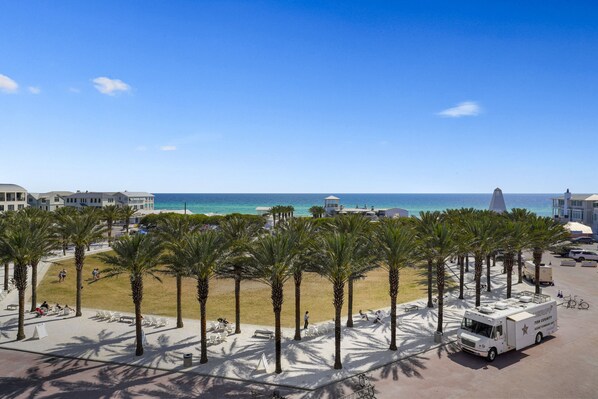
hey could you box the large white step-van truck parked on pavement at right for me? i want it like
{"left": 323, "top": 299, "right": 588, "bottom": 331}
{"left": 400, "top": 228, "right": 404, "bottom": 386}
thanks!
{"left": 457, "top": 291, "right": 558, "bottom": 362}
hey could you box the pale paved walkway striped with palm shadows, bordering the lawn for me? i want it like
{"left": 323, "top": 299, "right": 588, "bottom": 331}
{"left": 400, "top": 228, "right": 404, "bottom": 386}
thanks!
{"left": 0, "top": 252, "right": 529, "bottom": 397}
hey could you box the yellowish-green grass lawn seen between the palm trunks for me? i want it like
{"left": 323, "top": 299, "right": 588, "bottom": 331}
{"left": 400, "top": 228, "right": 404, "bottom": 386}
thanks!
{"left": 37, "top": 256, "right": 442, "bottom": 327}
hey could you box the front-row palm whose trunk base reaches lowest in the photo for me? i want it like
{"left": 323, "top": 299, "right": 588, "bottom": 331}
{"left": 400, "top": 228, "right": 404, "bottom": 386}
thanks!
{"left": 249, "top": 231, "right": 297, "bottom": 374}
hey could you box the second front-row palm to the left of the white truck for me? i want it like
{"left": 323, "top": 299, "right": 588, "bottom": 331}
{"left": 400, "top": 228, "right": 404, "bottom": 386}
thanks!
{"left": 375, "top": 219, "right": 417, "bottom": 351}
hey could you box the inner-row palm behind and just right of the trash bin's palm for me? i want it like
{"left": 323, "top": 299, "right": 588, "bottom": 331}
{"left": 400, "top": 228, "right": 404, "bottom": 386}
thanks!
{"left": 220, "top": 216, "right": 262, "bottom": 334}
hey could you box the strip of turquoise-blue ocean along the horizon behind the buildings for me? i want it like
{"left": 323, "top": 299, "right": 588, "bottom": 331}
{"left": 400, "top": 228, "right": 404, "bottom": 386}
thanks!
{"left": 155, "top": 193, "right": 559, "bottom": 216}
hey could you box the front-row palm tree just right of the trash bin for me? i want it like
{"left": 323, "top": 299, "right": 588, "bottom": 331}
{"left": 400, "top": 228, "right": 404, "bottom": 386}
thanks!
{"left": 182, "top": 230, "right": 228, "bottom": 363}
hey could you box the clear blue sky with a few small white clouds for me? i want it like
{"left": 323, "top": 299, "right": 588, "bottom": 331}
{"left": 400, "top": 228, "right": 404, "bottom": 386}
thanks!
{"left": 0, "top": 1, "right": 598, "bottom": 193}
